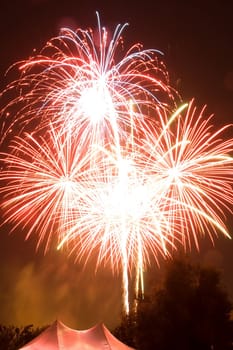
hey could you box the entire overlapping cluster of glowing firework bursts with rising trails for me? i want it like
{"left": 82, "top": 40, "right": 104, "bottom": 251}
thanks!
{"left": 0, "top": 14, "right": 233, "bottom": 312}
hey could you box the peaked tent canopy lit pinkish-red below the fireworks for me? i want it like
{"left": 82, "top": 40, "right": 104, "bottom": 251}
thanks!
{"left": 20, "top": 321, "right": 135, "bottom": 350}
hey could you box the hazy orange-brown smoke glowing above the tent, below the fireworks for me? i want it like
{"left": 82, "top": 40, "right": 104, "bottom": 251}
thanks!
{"left": 0, "top": 231, "right": 121, "bottom": 329}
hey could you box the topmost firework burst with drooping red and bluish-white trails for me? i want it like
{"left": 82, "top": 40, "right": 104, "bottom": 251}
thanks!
{"left": 2, "top": 15, "right": 175, "bottom": 147}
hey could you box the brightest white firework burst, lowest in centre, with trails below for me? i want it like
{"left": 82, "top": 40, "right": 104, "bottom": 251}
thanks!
{"left": 55, "top": 142, "right": 178, "bottom": 311}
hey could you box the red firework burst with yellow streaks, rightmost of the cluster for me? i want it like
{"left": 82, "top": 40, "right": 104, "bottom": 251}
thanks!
{"left": 143, "top": 103, "right": 233, "bottom": 248}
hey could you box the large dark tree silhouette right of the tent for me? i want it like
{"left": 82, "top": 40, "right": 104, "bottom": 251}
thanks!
{"left": 115, "top": 259, "right": 233, "bottom": 350}
